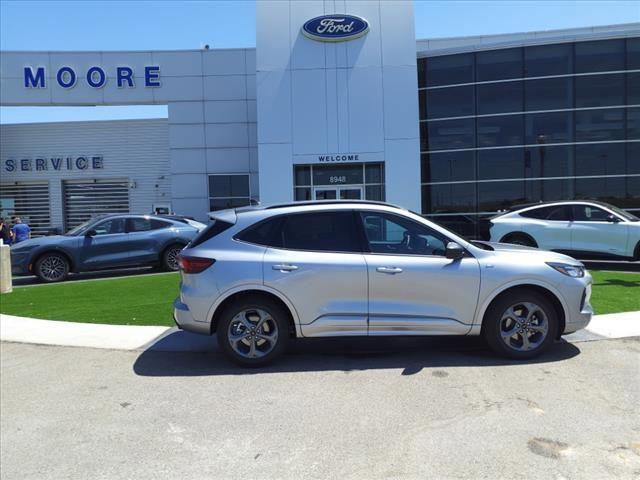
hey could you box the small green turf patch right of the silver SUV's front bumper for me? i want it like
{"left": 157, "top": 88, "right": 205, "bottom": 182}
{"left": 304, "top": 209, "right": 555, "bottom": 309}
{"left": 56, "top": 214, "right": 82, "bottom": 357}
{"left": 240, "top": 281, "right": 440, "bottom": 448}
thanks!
{"left": 591, "top": 271, "right": 640, "bottom": 314}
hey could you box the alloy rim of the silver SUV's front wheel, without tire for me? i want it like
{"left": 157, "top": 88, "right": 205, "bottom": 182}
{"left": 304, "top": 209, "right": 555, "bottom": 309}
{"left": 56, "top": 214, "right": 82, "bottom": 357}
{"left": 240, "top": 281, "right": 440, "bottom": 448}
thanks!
{"left": 500, "top": 302, "right": 549, "bottom": 352}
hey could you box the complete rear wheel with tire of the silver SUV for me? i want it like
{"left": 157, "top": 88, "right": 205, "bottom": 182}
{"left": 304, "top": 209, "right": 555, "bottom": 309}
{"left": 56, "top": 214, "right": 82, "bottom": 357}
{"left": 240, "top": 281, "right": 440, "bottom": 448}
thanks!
{"left": 217, "top": 296, "right": 289, "bottom": 368}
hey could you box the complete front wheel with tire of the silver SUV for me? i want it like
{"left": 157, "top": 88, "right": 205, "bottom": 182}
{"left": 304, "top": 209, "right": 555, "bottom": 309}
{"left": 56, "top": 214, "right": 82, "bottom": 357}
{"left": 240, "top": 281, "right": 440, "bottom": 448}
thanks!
{"left": 482, "top": 289, "right": 559, "bottom": 360}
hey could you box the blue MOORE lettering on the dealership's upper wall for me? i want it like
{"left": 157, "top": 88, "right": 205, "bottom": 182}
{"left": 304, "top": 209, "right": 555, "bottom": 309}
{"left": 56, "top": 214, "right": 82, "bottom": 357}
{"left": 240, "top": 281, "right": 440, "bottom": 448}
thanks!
{"left": 24, "top": 65, "right": 160, "bottom": 88}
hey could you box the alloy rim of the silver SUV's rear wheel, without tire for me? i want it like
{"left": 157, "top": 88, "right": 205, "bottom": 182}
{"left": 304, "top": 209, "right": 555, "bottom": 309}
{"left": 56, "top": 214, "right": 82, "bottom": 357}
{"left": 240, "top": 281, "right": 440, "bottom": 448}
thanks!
{"left": 227, "top": 308, "right": 278, "bottom": 359}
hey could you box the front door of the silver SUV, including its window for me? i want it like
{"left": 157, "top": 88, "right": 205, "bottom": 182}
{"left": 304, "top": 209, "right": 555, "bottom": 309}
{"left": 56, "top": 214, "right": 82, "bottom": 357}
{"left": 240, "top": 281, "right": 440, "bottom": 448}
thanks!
{"left": 360, "top": 211, "right": 480, "bottom": 335}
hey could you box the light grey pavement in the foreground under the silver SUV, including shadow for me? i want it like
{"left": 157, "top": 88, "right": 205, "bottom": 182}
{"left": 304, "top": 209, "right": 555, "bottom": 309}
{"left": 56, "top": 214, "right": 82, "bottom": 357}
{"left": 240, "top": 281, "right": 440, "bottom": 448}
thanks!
{"left": 0, "top": 338, "right": 640, "bottom": 480}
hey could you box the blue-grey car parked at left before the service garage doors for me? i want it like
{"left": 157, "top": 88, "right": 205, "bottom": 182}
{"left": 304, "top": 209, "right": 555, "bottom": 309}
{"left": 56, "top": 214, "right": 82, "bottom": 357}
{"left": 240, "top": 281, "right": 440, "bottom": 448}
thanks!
{"left": 11, "top": 215, "right": 204, "bottom": 282}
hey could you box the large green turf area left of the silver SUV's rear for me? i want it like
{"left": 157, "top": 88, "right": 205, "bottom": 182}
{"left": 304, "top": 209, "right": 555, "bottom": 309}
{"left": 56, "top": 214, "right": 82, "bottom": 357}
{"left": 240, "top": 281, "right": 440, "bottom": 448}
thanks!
{"left": 0, "top": 273, "right": 180, "bottom": 326}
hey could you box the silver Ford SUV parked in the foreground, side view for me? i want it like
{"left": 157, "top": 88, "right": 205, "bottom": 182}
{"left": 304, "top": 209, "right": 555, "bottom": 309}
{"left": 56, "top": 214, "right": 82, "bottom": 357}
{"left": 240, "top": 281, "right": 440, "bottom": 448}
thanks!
{"left": 174, "top": 201, "right": 593, "bottom": 366}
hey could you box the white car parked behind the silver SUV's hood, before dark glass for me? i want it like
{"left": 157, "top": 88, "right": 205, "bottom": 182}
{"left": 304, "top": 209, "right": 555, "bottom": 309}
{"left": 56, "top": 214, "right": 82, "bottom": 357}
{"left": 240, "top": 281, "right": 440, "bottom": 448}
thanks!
{"left": 490, "top": 201, "right": 640, "bottom": 260}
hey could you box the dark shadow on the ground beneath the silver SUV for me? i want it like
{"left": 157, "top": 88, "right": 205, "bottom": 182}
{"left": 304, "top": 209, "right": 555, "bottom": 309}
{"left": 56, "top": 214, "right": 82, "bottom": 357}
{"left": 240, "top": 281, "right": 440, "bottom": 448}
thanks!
{"left": 133, "top": 331, "right": 580, "bottom": 377}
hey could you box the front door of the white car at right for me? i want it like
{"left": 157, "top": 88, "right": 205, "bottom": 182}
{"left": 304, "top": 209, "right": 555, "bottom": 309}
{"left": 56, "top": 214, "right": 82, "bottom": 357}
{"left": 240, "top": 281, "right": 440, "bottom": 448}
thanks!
{"left": 571, "top": 204, "right": 629, "bottom": 256}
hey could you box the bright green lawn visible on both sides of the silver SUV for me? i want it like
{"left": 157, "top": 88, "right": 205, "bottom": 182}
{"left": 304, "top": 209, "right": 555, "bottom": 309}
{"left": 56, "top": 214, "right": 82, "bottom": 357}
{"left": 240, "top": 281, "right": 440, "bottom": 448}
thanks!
{"left": 0, "top": 271, "right": 640, "bottom": 326}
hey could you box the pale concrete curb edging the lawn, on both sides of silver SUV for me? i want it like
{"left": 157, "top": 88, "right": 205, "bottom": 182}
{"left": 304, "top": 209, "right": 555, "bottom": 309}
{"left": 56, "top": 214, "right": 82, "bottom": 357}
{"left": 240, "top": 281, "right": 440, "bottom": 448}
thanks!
{"left": 0, "top": 311, "right": 640, "bottom": 352}
